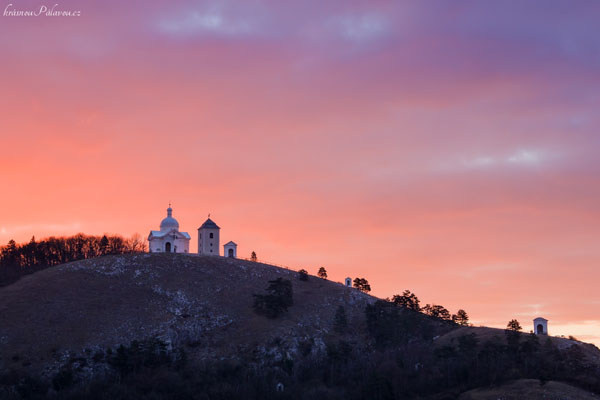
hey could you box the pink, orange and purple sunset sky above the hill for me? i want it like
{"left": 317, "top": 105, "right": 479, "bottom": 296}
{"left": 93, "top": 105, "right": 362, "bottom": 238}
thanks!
{"left": 0, "top": 0, "right": 600, "bottom": 345}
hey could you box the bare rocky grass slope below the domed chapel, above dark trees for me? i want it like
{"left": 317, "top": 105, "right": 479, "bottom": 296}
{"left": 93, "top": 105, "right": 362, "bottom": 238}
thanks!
{"left": 0, "top": 254, "right": 375, "bottom": 370}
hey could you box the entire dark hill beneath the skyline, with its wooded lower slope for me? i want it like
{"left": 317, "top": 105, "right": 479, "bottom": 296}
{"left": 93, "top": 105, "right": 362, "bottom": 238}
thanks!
{"left": 0, "top": 254, "right": 600, "bottom": 400}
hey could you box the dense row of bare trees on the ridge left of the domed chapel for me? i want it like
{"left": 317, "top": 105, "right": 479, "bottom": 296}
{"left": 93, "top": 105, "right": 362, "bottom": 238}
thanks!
{"left": 0, "top": 233, "right": 147, "bottom": 287}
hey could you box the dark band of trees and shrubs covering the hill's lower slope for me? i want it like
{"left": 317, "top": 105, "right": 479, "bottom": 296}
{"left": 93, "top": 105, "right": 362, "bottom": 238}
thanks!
{"left": 0, "top": 324, "right": 600, "bottom": 400}
